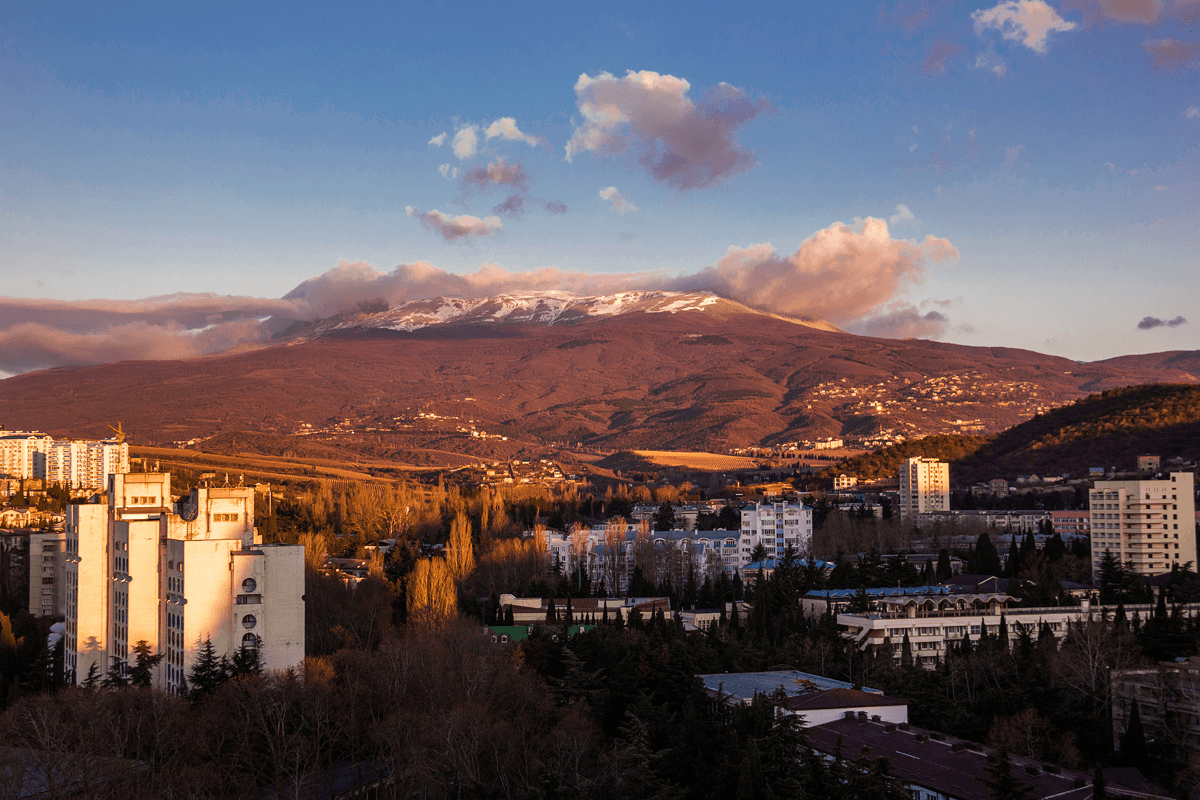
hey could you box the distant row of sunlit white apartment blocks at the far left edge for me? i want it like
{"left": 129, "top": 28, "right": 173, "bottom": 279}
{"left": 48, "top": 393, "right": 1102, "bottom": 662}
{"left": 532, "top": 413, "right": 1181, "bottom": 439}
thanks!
{"left": 0, "top": 431, "right": 130, "bottom": 491}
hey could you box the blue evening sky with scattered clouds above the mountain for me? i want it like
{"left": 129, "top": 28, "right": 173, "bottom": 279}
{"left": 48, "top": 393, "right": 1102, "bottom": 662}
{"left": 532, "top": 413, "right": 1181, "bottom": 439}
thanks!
{"left": 0, "top": 0, "right": 1200, "bottom": 377}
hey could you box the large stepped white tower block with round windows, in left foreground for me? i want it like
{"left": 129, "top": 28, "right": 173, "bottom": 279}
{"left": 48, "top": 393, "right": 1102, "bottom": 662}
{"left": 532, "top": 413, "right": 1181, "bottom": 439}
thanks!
{"left": 60, "top": 473, "right": 305, "bottom": 691}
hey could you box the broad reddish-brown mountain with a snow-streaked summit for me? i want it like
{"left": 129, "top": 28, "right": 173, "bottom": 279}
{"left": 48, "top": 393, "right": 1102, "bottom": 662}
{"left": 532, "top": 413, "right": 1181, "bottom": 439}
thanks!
{"left": 0, "top": 291, "right": 1196, "bottom": 463}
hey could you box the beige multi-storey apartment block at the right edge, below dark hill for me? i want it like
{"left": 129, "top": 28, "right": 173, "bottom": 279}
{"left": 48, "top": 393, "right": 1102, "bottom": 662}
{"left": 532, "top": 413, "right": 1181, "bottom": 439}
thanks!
{"left": 1088, "top": 473, "right": 1196, "bottom": 577}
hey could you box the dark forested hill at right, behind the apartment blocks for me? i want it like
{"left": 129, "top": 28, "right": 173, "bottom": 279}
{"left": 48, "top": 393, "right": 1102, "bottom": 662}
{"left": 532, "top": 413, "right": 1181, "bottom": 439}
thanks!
{"left": 950, "top": 384, "right": 1200, "bottom": 485}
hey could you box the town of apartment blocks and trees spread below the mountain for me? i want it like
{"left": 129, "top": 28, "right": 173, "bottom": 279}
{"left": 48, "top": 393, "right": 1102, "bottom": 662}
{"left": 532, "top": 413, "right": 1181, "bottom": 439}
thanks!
{"left": 0, "top": 417, "right": 1200, "bottom": 799}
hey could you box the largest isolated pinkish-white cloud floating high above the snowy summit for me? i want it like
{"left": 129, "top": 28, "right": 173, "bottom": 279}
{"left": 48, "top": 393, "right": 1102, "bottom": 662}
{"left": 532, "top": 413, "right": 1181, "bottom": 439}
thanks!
{"left": 566, "top": 71, "right": 770, "bottom": 191}
